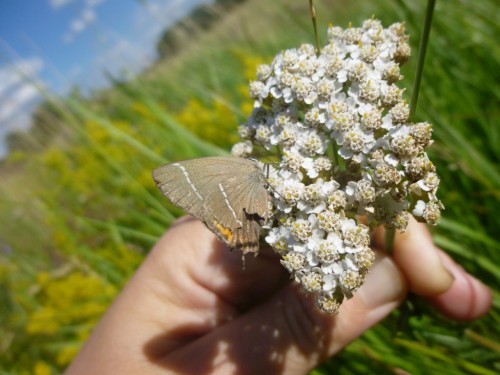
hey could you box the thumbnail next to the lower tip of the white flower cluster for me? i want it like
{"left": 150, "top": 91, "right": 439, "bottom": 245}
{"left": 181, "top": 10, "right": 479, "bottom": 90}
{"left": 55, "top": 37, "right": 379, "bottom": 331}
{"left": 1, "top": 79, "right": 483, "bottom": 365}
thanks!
{"left": 359, "top": 257, "right": 406, "bottom": 309}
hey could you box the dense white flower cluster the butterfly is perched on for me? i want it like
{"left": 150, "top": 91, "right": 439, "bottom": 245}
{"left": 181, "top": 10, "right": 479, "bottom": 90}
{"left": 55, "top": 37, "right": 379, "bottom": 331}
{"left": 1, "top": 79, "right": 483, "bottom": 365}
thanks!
{"left": 233, "top": 19, "right": 442, "bottom": 313}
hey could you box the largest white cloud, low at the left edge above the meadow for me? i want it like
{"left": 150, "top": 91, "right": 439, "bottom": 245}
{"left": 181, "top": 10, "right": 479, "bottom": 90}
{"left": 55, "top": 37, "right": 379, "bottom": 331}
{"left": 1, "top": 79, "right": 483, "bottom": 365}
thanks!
{"left": 0, "top": 57, "right": 44, "bottom": 155}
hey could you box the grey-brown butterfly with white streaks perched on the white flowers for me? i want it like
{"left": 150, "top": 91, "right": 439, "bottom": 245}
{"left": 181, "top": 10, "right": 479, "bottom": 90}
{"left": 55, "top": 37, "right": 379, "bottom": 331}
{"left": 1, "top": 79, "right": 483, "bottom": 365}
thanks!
{"left": 153, "top": 157, "right": 270, "bottom": 253}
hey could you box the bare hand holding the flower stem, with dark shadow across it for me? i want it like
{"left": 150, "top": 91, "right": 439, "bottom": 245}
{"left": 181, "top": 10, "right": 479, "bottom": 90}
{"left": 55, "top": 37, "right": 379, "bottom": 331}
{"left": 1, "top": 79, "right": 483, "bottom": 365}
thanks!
{"left": 66, "top": 218, "right": 492, "bottom": 375}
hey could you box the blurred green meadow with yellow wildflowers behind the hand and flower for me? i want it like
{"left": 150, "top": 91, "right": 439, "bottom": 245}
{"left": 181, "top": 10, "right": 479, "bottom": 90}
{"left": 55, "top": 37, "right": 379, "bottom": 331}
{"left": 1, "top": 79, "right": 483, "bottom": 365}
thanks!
{"left": 0, "top": 0, "right": 500, "bottom": 375}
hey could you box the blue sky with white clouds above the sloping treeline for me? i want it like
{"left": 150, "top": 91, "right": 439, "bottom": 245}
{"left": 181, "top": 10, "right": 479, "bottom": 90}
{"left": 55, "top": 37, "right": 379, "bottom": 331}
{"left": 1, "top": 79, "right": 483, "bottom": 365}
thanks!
{"left": 0, "top": 0, "right": 211, "bottom": 156}
